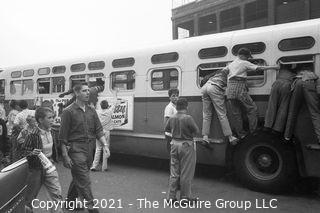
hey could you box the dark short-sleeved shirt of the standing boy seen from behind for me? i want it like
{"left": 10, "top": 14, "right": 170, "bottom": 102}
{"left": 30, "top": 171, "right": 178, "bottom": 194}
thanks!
{"left": 165, "top": 112, "right": 199, "bottom": 140}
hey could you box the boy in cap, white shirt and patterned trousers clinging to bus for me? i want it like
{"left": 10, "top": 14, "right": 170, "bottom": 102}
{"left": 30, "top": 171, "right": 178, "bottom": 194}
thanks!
{"left": 224, "top": 48, "right": 279, "bottom": 139}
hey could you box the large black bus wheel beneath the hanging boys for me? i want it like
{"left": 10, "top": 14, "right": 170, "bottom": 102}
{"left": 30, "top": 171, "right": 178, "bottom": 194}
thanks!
{"left": 234, "top": 132, "right": 297, "bottom": 193}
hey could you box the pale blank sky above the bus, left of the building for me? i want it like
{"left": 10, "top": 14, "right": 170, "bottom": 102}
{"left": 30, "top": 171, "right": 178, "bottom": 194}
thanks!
{"left": 0, "top": 0, "right": 172, "bottom": 68}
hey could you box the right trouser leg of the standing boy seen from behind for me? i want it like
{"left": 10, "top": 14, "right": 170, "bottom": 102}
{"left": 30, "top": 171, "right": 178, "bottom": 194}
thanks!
{"left": 179, "top": 141, "right": 196, "bottom": 199}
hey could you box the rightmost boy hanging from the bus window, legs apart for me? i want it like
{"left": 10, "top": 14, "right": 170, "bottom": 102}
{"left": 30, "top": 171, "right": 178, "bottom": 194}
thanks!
{"left": 285, "top": 64, "right": 320, "bottom": 149}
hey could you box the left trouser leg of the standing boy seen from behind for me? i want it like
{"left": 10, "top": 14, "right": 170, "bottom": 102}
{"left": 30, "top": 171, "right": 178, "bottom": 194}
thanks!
{"left": 168, "top": 142, "right": 180, "bottom": 199}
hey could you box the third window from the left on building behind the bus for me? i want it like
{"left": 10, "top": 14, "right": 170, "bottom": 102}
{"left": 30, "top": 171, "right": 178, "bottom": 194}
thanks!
{"left": 220, "top": 7, "right": 241, "bottom": 31}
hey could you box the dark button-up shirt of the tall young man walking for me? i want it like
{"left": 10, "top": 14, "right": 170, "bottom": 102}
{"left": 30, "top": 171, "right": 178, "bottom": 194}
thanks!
{"left": 59, "top": 103, "right": 104, "bottom": 143}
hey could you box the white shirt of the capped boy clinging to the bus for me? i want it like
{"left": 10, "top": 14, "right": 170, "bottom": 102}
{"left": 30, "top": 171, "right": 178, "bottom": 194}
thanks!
{"left": 227, "top": 58, "right": 258, "bottom": 79}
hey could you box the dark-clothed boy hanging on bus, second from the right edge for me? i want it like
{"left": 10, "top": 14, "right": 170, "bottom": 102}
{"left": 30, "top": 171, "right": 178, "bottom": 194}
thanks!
{"left": 264, "top": 64, "right": 296, "bottom": 136}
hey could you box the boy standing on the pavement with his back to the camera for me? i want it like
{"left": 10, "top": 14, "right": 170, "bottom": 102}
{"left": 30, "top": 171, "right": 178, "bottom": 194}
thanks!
{"left": 165, "top": 98, "right": 199, "bottom": 202}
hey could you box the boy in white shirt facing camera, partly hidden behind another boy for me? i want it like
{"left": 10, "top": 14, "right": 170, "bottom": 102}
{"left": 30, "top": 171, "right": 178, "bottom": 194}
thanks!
{"left": 164, "top": 88, "right": 179, "bottom": 153}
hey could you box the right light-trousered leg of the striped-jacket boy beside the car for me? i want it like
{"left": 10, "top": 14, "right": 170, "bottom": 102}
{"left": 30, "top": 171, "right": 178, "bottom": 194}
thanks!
{"left": 43, "top": 170, "right": 63, "bottom": 213}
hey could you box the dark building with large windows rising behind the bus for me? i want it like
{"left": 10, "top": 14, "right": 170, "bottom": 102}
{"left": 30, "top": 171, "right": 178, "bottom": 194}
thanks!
{"left": 172, "top": 0, "right": 320, "bottom": 39}
